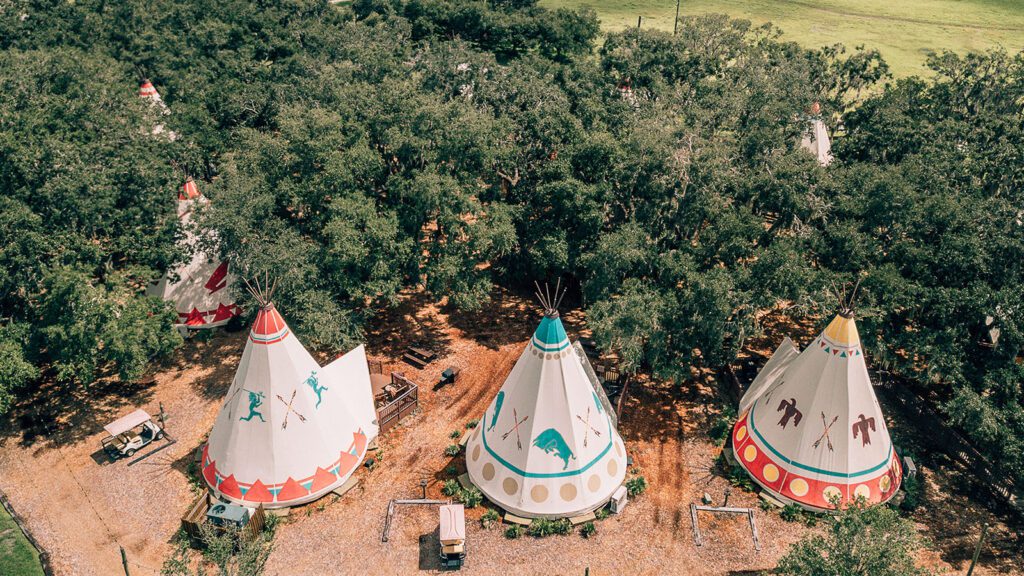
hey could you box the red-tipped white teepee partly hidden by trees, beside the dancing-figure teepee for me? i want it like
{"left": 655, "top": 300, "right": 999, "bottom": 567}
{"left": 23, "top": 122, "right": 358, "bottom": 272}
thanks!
{"left": 146, "top": 178, "right": 241, "bottom": 328}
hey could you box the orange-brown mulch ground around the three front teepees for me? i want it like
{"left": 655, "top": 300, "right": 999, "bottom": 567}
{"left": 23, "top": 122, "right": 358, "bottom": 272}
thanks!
{"left": 0, "top": 291, "right": 1024, "bottom": 576}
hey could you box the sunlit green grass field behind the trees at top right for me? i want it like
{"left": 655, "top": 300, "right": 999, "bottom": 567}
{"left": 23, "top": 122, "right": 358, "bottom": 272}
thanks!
{"left": 541, "top": 0, "right": 1024, "bottom": 76}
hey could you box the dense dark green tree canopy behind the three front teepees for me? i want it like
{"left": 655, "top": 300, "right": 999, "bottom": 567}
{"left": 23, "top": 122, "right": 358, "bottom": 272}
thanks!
{"left": 0, "top": 0, "right": 1024, "bottom": 478}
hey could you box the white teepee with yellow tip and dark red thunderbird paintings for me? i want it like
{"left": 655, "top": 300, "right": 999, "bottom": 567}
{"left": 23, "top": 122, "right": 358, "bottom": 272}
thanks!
{"left": 732, "top": 306, "right": 902, "bottom": 511}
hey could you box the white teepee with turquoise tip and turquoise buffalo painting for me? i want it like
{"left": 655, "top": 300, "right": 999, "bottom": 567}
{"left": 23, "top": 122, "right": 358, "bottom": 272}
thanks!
{"left": 466, "top": 290, "right": 626, "bottom": 518}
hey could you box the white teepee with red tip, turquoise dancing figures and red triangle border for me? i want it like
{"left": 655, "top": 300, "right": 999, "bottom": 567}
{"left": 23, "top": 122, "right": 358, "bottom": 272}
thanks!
{"left": 203, "top": 291, "right": 377, "bottom": 508}
